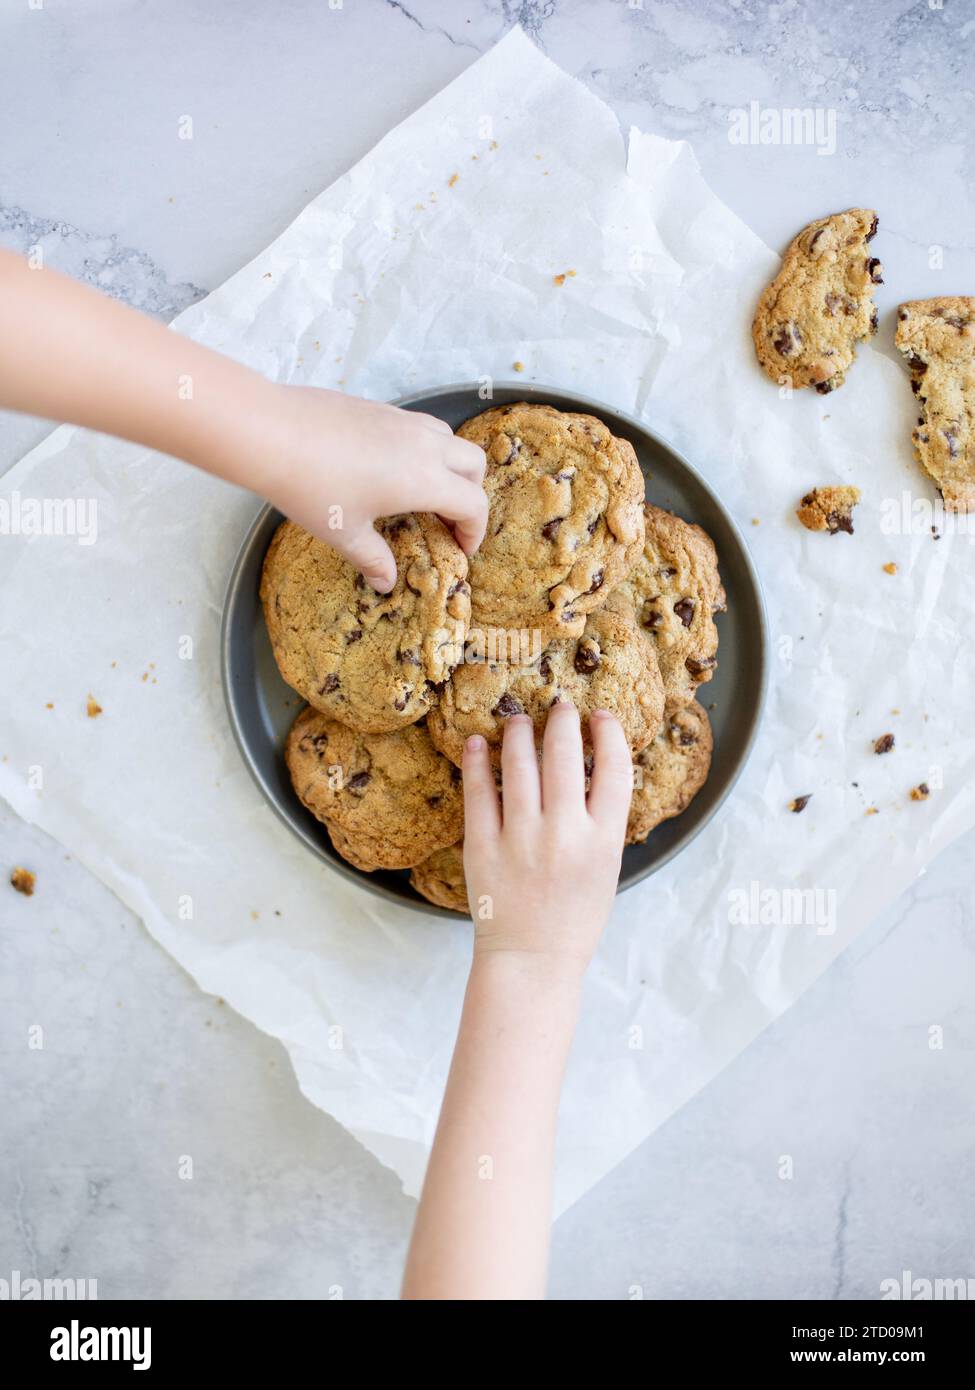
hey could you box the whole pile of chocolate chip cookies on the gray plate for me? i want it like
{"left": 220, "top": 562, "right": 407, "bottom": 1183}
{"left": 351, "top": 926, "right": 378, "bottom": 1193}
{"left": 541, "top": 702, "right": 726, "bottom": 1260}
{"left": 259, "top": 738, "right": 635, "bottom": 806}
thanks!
{"left": 261, "top": 403, "right": 725, "bottom": 912}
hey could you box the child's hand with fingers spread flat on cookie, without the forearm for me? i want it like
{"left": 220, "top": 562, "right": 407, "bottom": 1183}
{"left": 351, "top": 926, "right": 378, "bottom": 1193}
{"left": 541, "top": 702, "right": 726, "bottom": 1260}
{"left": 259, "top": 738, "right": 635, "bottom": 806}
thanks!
{"left": 463, "top": 702, "right": 633, "bottom": 969}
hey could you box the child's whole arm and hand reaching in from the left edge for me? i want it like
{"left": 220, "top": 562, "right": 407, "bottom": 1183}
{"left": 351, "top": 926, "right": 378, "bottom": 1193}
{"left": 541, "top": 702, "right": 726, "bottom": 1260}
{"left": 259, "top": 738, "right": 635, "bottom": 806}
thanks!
{"left": 0, "top": 250, "right": 487, "bottom": 592}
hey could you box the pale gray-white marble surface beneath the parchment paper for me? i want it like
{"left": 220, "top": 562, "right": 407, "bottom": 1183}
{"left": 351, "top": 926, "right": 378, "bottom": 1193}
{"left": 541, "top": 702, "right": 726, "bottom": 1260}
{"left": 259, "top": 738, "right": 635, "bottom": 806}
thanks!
{"left": 0, "top": 0, "right": 975, "bottom": 1298}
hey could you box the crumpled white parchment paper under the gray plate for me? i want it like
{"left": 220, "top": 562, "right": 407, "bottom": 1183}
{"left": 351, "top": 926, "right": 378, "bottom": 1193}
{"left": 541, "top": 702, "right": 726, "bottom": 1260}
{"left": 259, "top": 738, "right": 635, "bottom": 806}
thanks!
{"left": 0, "top": 32, "right": 975, "bottom": 1209}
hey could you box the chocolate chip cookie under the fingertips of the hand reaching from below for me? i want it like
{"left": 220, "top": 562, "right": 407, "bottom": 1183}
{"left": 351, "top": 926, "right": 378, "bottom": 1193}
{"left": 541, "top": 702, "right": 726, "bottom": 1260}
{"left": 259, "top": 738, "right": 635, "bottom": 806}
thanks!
{"left": 427, "top": 595, "right": 663, "bottom": 766}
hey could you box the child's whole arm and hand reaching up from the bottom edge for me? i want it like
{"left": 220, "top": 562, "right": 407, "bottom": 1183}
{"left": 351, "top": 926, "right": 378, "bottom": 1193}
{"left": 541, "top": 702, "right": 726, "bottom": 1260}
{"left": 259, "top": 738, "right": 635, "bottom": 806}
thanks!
{"left": 403, "top": 703, "right": 633, "bottom": 1300}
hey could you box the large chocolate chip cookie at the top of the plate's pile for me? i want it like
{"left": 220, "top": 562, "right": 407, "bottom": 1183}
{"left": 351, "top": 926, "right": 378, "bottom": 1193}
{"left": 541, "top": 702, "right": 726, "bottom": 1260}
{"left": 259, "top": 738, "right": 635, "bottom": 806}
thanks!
{"left": 458, "top": 402, "right": 644, "bottom": 642}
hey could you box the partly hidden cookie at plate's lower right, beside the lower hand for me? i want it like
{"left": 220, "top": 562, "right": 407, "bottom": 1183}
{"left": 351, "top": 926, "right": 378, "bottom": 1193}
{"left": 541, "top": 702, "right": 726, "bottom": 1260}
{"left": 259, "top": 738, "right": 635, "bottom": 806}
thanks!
{"left": 626, "top": 701, "right": 714, "bottom": 845}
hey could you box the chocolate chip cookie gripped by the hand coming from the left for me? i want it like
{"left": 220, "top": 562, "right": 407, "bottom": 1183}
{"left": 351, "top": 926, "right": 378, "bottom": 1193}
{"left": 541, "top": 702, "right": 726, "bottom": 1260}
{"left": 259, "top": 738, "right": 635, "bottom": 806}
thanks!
{"left": 260, "top": 513, "right": 470, "bottom": 734}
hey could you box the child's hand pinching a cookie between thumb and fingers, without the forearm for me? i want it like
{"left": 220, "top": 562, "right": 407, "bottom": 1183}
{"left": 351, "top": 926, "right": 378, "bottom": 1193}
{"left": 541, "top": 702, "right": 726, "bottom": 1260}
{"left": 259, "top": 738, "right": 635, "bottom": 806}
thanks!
{"left": 255, "top": 386, "right": 487, "bottom": 594}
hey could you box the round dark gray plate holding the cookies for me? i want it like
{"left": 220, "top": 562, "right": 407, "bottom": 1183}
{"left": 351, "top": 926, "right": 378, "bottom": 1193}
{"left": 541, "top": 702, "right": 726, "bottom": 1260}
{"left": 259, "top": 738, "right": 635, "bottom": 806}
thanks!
{"left": 221, "top": 382, "right": 768, "bottom": 917}
